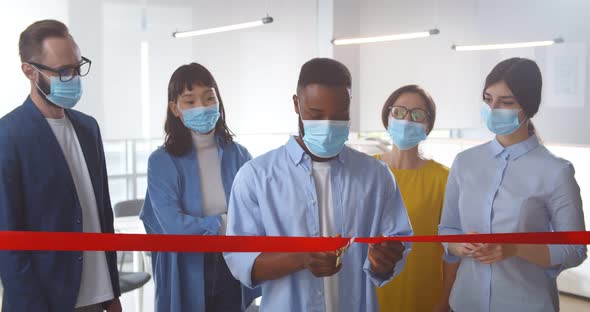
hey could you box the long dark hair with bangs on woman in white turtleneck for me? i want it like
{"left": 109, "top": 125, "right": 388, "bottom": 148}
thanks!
{"left": 164, "top": 63, "right": 234, "bottom": 156}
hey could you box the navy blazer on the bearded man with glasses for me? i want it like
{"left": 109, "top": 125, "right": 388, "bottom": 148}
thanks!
{"left": 0, "top": 97, "right": 121, "bottom": 312}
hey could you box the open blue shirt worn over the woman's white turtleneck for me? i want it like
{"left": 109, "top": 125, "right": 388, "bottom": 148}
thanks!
{"left": 140, "top": 136, "right": 260, "bottom": 312}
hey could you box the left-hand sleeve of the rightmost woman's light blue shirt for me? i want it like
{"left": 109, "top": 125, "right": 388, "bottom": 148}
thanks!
{"left": 438, "top": 159, "right": 463, "bottom": 263}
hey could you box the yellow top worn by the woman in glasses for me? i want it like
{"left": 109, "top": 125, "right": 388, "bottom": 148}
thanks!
{"left": 375, "top": 155, "right": 449, "bottom": 312}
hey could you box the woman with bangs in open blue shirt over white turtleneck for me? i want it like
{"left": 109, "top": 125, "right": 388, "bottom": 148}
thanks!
{"left": 140, "top": 63, "right": 260, "bottom": 312}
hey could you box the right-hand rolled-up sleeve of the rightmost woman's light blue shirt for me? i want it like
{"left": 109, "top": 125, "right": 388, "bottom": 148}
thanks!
{"left": 547, "top": 163, "right": 587, "bottom": 276}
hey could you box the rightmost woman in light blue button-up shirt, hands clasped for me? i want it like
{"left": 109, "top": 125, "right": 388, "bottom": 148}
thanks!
{"left": 439, "top": 58, "right": 586, "bottom": 312}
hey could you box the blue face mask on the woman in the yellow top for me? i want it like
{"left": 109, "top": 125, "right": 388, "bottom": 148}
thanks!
{"left": 387, "top": 117, "right": 426, "bottom": 150}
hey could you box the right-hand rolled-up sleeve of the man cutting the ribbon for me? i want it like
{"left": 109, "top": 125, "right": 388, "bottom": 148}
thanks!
{"left": 363, "top": 168, "right": 414, "bottom": 287}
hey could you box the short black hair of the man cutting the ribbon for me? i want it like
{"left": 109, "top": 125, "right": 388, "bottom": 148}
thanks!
{"left": 297, "top": 58, "right": 352, "bottom": 93}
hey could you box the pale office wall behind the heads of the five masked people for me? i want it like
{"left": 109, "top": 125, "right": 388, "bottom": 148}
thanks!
{"left": 0, "top": 0, "right": 590, "bottom": 144}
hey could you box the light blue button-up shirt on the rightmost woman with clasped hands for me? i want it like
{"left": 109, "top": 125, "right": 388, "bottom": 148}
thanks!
{"left": 439, "top": 134, "right": 586, "bottom": 312}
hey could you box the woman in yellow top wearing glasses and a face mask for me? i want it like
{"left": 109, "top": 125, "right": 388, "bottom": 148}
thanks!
{"left": 375, "top": 85, "right": 458, "bottom": 312}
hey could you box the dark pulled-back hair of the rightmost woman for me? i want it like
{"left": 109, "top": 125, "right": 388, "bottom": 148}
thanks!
{"left": 482, "top": 57, "right": 543, "bottom": 132}
